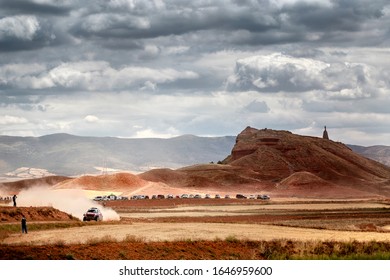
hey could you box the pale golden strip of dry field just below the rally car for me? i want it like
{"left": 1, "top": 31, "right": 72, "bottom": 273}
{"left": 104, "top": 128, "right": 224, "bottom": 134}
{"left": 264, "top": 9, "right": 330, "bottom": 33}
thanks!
{"left": 3, "top": 223, "right": 390, "bottom": 245}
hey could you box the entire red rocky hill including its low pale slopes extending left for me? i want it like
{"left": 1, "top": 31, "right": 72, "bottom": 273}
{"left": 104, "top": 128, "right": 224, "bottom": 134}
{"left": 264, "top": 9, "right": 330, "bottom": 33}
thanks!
{"left": 140, "top": 127, "right": 390, "bottom": 198}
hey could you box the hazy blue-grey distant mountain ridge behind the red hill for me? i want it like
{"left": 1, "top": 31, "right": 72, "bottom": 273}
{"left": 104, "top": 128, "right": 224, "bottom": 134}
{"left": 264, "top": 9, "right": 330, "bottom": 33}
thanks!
{"left": 0, "top": 133, "right": 390, "bottom": 182}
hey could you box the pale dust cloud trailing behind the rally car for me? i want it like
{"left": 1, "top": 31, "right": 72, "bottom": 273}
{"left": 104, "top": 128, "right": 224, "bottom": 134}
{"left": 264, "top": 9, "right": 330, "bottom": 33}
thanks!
{"left": 17, "top": 186, "right": 120, "bottom": 221}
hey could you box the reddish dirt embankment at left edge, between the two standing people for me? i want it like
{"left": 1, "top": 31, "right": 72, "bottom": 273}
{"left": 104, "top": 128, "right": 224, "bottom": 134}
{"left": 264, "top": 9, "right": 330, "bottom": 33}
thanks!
{"left": 0, "top": 206, "right": 75, "bottom": 222}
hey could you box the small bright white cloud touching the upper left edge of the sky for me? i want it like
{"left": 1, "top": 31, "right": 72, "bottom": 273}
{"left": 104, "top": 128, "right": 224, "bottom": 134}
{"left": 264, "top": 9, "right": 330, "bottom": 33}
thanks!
{"left": 0, "top": 15, "right": 40, "bottom": 41}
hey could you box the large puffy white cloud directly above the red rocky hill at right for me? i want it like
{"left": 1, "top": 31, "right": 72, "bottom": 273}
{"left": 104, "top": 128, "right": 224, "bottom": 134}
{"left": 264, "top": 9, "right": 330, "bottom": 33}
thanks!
{"left": 227, "top": 53, "right": 389, "bottom": 99}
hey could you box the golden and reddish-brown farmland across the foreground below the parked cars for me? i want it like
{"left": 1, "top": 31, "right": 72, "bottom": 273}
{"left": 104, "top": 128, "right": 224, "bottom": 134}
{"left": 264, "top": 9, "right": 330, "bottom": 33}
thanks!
{"left": 0, "top": 199, "right": 390, "bottom": 259}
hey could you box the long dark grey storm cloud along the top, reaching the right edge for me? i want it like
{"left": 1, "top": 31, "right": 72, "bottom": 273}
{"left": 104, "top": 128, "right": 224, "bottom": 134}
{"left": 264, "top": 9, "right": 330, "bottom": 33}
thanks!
{"left": 71, "top": 0, "right": 386, "bottom": 46}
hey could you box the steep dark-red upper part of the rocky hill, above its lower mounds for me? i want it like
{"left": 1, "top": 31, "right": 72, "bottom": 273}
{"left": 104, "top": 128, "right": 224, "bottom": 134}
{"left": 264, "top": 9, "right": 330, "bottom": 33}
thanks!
{"left": 224, "top": 127, "right": 390, "bottom": 184}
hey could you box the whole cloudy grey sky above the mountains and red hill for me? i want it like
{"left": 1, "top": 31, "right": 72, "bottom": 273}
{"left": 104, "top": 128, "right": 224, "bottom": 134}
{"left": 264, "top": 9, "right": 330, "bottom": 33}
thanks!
{"left": 0, "top": 0, "right": 390, "bottom": 145}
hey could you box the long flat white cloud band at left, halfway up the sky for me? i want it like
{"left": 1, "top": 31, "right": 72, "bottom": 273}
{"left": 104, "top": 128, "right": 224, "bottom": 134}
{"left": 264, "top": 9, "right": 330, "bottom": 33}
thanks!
{"left": 0, "top": 61, "right": 199, "bottom": 91}
